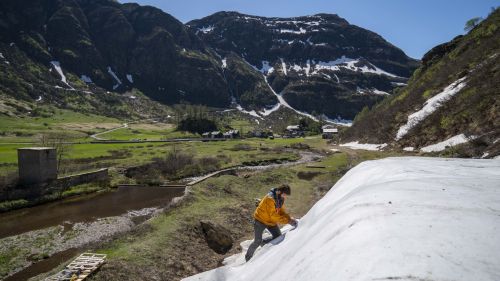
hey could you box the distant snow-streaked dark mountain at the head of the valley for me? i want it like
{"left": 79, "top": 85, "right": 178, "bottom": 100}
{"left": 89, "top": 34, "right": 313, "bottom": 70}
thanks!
{"left": 187, "top": 12, "right": 419, "bottom": 119}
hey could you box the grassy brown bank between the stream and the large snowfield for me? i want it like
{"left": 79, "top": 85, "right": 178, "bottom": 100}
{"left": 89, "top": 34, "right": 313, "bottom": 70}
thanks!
{"left": 56, "top": 151, "right": 394, "bottom": 280}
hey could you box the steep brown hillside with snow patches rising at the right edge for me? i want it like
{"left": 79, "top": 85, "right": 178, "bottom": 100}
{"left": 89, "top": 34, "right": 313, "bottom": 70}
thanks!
{"left": 343, "top": 9, "right": 500, "bottom": 157}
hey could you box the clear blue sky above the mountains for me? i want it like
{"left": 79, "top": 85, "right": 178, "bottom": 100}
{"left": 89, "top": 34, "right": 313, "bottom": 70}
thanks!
{"left": 120, "top": 0, "right": 500, "bottom": 59}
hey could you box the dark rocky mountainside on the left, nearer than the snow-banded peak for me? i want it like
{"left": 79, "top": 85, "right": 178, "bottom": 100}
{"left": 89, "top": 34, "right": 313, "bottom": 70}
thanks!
{"left": 0, "top": 0, "right": 231, "bottom": 111}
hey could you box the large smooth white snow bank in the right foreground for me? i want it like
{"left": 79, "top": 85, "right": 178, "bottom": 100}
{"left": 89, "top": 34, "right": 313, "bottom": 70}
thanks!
{"left": 185, "top": 157, "right": 500, "bottom": 281}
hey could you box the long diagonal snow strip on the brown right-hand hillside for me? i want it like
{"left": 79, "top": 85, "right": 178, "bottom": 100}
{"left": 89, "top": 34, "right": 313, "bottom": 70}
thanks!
{"left": 395, "top": 76, "right": 467, "bottom": 141}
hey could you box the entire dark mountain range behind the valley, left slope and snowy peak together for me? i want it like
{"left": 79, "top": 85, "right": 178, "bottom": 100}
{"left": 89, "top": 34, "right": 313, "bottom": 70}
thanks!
{"left": 0, "top": 0, "right": 419, "bottom": 119}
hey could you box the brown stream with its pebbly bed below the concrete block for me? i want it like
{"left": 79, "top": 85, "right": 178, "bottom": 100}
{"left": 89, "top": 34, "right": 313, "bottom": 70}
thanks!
{"left": 0, "top": 186, "right": 184, "bottom": 281}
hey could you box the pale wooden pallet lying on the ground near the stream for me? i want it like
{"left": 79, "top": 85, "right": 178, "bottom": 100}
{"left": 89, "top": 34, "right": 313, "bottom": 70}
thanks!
{"left": 45, "top": 253, "right": 106, "bottom": 281}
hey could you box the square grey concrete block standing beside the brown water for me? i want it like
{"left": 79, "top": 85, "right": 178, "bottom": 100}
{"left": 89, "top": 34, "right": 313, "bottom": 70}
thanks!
{"left": 17, "top": 147, "right": 57, "bottom": 185}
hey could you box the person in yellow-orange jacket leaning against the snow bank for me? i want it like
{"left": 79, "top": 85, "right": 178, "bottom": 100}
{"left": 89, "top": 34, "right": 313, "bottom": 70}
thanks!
{"left": 245, "top": 184, "right": 297, "bottom": 261}
